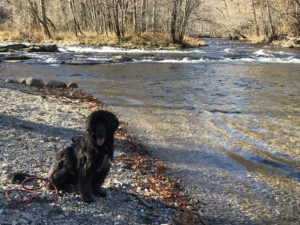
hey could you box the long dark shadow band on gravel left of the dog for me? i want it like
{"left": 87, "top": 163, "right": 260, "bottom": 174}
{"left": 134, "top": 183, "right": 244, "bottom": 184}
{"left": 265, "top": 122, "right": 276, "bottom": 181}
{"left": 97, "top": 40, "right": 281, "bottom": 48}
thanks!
{"left": 0, "top": 114, "right": 80, "bottom": 138}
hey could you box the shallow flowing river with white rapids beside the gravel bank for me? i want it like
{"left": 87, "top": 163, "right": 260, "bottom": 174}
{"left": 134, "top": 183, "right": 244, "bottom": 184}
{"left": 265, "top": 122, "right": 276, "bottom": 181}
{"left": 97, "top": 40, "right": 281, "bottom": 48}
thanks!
{"left": 0, "top": 39, "right": 300, "bottom": 224}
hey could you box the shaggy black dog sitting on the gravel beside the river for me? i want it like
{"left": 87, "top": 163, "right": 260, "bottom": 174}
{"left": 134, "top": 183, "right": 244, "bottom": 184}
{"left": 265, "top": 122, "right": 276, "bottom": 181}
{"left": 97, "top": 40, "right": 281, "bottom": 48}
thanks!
{"left": 49, "top": 110, "right": 119, "bottom": 202}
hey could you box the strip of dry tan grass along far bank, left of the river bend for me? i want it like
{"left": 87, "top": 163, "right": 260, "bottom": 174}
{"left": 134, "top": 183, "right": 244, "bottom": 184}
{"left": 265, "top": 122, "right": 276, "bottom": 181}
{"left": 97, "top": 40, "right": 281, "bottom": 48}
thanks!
{"left": 0, "top": 29, "right": 205, "bottom": 50}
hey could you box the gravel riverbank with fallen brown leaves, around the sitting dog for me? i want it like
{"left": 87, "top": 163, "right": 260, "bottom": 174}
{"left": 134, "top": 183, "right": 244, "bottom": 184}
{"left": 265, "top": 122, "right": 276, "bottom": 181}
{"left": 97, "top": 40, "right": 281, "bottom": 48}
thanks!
{"left": 0, "top": 80, "right": 204, "bottom": 225}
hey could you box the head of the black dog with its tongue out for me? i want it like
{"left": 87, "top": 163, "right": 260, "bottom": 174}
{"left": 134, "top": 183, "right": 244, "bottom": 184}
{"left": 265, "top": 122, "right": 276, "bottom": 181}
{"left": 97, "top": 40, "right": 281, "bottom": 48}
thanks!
{"left": 86, "top": 110, "right": 119, "bottom": 146}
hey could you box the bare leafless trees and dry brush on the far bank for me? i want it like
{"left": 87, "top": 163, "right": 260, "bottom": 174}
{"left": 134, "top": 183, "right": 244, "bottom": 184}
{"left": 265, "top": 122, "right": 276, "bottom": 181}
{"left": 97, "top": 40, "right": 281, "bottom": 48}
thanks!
{"left": 0, "top": 0, "right": 300, "bottom": 46}
